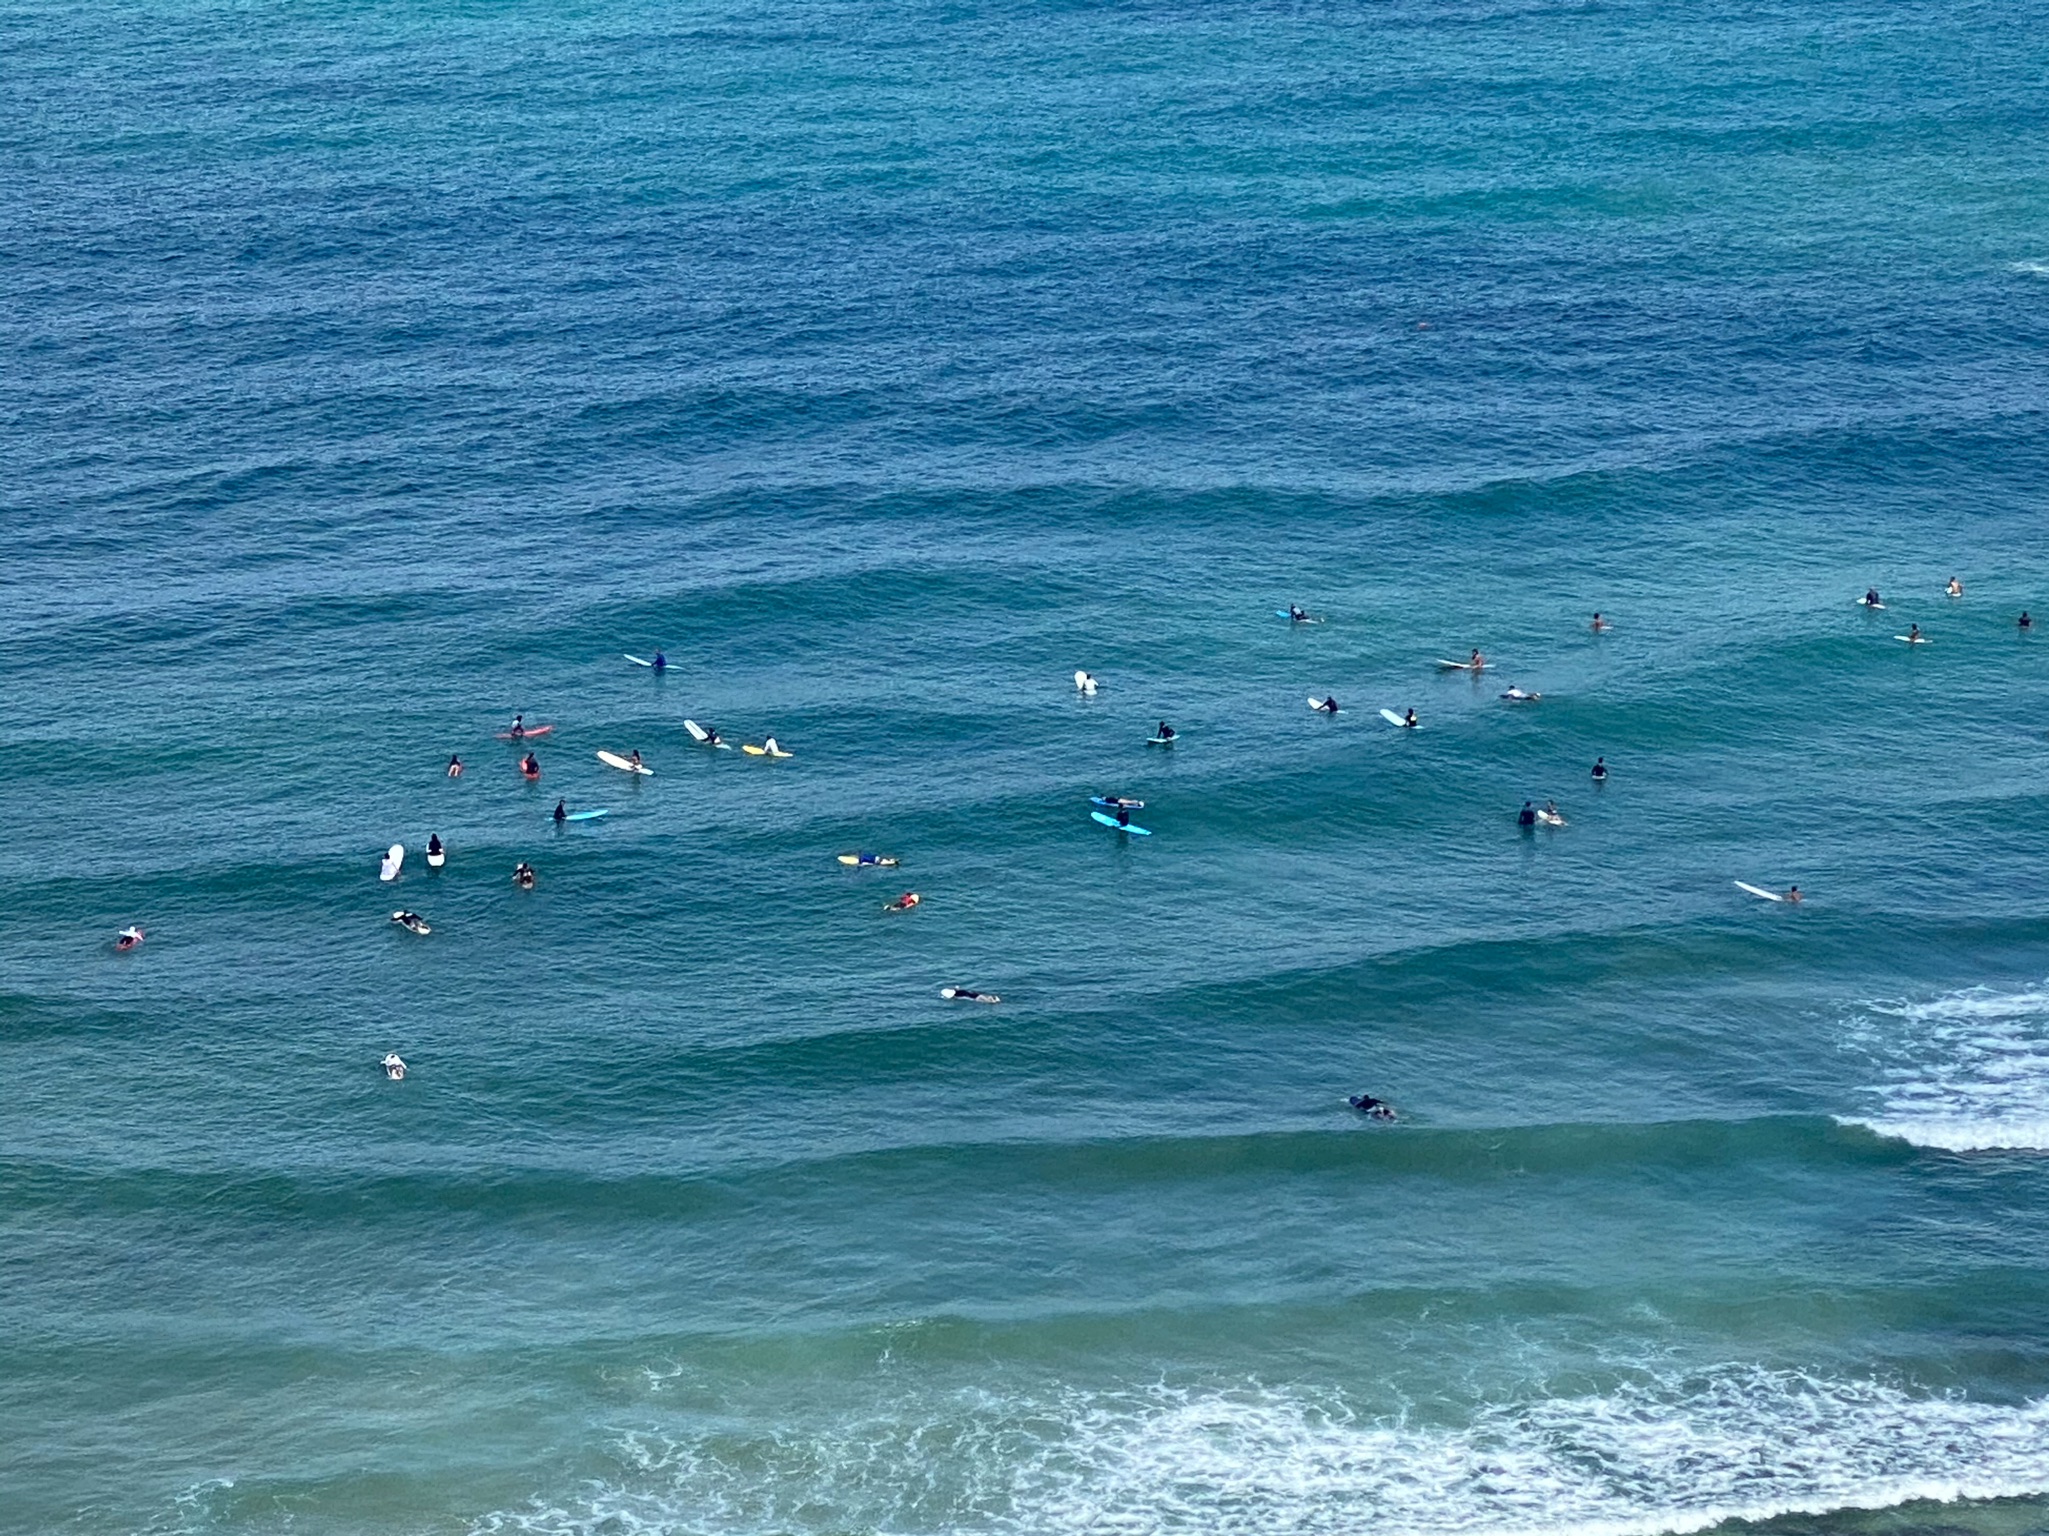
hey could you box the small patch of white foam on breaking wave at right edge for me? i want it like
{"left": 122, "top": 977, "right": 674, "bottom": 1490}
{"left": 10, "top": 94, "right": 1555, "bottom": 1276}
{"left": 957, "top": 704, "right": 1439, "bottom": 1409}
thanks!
{"left": 1842, "top": 987, "right": 2049, "bottom": 1151}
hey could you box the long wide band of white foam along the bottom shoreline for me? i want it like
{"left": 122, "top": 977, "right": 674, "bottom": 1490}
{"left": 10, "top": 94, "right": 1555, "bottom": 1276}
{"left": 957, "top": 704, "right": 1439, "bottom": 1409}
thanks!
{"left": 477, "top": 1366, "right": 2049, "bottom": 1536}
